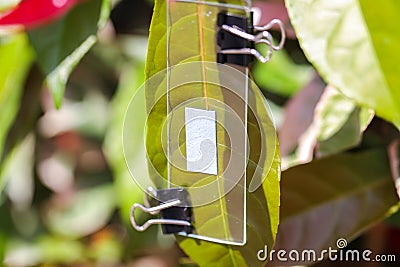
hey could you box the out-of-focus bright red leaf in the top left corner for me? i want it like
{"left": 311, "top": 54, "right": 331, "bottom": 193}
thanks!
{"left": 0, "top": 0, "right": 79, "bottom": 28}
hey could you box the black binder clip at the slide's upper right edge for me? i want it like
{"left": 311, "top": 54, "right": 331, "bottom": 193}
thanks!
{"left": 217, "top": 12, "right": 286, "bottom": 67}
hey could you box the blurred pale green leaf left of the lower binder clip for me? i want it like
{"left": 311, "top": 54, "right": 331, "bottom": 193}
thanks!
{"left": 45, "top": 184, "right": 116, "bottom": 238}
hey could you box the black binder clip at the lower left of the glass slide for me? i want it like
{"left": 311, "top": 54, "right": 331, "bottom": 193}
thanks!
{"left": 130, "top": 187, "right": 193, "bottom": 234}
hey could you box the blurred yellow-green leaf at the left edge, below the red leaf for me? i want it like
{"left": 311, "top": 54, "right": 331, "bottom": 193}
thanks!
{"left": 0, "top": 34, "right": 33, "bottom": 176}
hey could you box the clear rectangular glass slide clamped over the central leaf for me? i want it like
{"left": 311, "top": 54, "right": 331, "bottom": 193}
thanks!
{"left": 162, "top": 0, "right": 249, "bottom": 245}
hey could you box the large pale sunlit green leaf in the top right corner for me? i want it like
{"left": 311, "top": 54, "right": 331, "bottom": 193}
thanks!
{"left": 286, "top": 0, "right": 400, "bottom": 128}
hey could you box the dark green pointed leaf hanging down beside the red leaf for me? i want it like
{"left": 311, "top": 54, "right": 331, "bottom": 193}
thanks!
{"left": 28, "top": 0, "right": 110, "bottom": 107}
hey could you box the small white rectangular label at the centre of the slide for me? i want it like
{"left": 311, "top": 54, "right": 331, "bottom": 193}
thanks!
{"left": 185, "top": 108, "right": 218, "bottom": 175}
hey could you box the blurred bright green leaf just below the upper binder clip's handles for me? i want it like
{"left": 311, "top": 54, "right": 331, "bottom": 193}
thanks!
{"left": 252, "top": 45, "right": 314, "bottom": 97}
